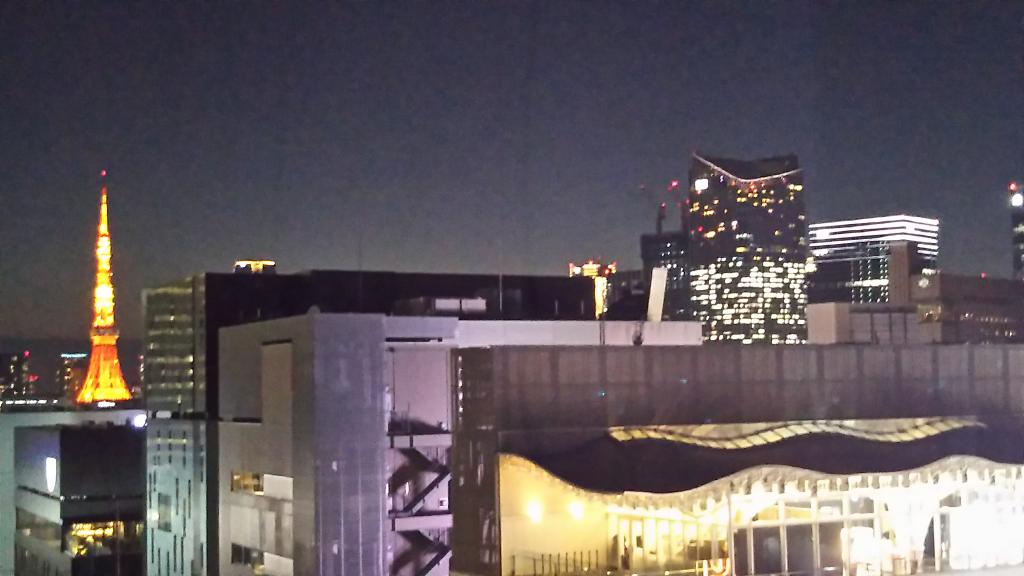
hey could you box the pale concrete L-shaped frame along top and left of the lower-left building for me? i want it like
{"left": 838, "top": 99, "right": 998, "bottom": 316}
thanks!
{"left": 0, "top": 410, "right": 142, "bottom": 576}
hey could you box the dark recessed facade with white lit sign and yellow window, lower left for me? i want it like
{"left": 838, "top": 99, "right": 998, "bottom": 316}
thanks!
{"left": 14, "top": 425, "right": 145, "bottom": 576}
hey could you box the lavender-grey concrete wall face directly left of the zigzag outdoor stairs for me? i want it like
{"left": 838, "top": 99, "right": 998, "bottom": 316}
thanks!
{"left": 311, "top": 316, "right": 387, "bottom": 576}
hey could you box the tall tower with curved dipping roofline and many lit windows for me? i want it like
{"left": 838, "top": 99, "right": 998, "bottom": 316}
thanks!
{"left": 689, "top": 154, "right": 807, "bottom": 343}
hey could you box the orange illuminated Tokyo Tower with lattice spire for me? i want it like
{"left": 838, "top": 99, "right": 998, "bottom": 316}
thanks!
{"left": 75, "top": 170, "right": 131, "bottom": 404}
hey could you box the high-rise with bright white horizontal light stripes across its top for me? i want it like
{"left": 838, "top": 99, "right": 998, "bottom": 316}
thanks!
{"left": 807, "top": 214, "right": 939, "bottom": 304}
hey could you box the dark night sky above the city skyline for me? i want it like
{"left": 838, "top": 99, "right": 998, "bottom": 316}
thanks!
{"left": 0, "top": 0, "right": 1024, "bottom": 337}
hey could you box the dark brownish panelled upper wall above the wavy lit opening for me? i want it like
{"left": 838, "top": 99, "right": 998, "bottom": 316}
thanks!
{"left": 459, "top": 344, "right": 1024, "bottom": 429}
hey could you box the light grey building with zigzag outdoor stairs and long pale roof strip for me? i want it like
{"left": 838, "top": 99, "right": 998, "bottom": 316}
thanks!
{"left": 210, "top": 314, "right": 700, "bottom": 576}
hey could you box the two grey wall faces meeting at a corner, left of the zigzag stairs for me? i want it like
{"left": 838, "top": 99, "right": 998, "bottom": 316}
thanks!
{"left": 218, "top": 315, "right": 387, "bottom": 575}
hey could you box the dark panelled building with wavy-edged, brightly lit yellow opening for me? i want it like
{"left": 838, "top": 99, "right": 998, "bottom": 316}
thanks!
{"left": 452, "top": 344, "right": 1024, "bottom": 576}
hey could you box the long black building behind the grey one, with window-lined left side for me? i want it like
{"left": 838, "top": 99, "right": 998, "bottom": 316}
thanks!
{"left": 143, "top": 271, "right": 595, "bottom": 416}
